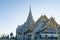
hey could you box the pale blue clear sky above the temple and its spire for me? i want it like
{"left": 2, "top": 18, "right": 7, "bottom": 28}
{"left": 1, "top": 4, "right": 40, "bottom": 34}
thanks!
{"left": 0, "top": 0, "right": 60, "bottom": 34}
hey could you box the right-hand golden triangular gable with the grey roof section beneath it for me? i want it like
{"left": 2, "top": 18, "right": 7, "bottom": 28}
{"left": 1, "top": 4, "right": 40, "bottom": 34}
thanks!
{"left": 41, "top": 17, "right": 59, "bottom": 33}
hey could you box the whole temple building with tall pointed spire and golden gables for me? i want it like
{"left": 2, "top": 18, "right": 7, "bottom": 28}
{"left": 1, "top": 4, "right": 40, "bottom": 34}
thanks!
{"left": 16, "top": 7, "right": 60, "bottom": 40}
